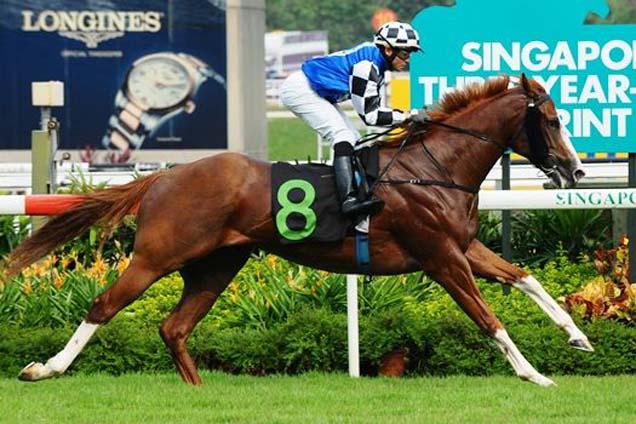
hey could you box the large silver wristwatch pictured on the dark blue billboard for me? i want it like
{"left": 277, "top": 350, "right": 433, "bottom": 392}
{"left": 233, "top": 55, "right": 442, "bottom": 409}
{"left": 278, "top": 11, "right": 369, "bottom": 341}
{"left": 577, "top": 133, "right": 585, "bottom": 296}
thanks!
{"left": 102, "top": 52, "right": 225, "bottom": 151}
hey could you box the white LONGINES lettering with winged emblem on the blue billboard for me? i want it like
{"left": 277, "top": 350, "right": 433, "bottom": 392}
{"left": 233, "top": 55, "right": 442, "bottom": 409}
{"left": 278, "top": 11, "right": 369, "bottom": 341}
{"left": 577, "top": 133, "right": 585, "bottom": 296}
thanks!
{"left": 22, "top": 10, "right": 163, "bottom": 48}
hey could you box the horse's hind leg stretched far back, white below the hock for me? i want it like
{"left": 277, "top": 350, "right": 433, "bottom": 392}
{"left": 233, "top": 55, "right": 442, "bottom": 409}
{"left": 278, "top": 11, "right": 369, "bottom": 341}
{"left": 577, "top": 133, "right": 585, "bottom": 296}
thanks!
{"left": 18, "top": 257, "right": 161, "bottom": 381}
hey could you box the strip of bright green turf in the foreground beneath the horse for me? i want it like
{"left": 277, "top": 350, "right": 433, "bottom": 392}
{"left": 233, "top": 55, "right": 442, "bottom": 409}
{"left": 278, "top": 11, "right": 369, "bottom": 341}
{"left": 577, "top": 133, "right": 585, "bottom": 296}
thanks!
{"left": 0, "top": 373, "right": 636, "bottom": 424}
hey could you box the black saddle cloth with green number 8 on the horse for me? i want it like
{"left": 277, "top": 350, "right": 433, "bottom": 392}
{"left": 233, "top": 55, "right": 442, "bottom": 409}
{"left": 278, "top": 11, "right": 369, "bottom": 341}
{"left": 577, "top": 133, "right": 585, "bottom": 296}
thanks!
{"left": 271, "top": 146, "right": 379, "bottom": 244}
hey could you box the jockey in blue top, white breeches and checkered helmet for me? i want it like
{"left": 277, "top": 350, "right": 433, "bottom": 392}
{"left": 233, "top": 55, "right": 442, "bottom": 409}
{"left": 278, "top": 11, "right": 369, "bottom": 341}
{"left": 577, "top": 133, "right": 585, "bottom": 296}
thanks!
{"left": 280, "top": 22, "right": 420, "bottom": 215}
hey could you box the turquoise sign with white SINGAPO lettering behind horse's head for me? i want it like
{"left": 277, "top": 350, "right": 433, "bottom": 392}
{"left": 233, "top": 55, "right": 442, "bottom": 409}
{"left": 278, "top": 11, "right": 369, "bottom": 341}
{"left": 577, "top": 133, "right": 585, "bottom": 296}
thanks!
{"left": 411, "top": 0, "right": 636, "bottom": 153}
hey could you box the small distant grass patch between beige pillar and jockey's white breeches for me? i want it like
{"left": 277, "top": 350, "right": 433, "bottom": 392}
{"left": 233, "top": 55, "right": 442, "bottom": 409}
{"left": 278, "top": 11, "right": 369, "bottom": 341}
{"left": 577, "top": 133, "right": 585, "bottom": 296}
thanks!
{"left": 267, "top": 118, "right": 328, "bottom": 161}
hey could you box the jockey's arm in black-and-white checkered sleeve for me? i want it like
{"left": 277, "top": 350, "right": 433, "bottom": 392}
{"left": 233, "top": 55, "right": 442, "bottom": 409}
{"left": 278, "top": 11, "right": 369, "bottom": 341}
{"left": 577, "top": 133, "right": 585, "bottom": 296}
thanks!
{"left": 349, "top": 60, "right": 408, "bottom": 126}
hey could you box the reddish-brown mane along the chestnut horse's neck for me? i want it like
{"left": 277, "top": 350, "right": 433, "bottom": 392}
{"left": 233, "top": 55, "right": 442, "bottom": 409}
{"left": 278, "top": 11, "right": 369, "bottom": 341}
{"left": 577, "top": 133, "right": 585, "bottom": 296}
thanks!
{"left": 382, "top": 75, "right": 510, "bottom": 147}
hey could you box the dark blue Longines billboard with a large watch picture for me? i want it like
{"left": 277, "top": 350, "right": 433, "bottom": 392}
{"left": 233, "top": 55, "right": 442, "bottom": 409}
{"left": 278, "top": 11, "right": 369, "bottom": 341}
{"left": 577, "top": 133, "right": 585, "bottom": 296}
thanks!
{"left": 0, "top": 0, "right": 227, "bottom": 156}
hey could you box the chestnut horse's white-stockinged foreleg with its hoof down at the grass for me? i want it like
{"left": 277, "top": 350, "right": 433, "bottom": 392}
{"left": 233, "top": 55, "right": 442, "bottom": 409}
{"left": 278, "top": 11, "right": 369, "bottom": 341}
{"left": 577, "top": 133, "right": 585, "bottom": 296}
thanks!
{"left": 424, "top": 248, "right": 554, "bottom": 386}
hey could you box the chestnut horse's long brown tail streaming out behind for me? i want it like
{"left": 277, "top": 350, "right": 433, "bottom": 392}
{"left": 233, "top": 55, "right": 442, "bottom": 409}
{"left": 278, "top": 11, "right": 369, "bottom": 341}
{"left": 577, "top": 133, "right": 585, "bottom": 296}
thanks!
{"left": 5, "top": 172, "right": 163, "bottom": 278}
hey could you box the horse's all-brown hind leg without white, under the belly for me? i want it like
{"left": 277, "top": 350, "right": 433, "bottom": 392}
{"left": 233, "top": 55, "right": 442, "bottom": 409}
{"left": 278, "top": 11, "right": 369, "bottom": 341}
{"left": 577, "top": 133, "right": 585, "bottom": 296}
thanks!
{"left": 160, "top": 246, "right": 252, "bottom": 385}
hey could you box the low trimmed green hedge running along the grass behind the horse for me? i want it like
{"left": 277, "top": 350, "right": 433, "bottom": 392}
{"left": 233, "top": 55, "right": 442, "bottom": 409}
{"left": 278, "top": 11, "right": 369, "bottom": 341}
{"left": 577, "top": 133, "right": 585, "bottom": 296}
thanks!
{"left": 0, "top": 308, "right": 636, "bottom": 377}
